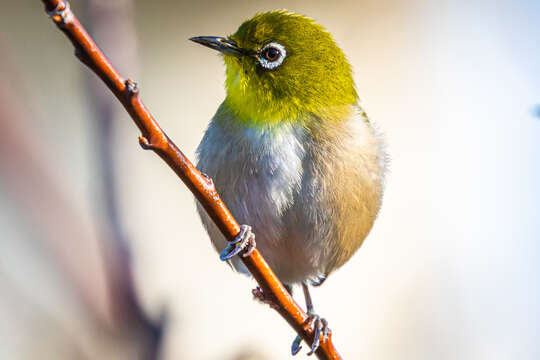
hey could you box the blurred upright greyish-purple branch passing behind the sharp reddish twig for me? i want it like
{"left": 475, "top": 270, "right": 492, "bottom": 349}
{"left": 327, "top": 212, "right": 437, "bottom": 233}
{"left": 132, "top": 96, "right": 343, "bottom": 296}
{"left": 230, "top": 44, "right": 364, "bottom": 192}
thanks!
{"left": 86, "top": 0, "right": 166, "bottom": 359}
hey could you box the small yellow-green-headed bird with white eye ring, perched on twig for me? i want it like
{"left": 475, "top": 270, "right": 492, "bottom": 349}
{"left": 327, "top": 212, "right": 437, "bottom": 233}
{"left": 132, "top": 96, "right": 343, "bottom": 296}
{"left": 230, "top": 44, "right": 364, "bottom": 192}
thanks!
{"left": 190, "top": 10, "right": 387, "bottom": 354}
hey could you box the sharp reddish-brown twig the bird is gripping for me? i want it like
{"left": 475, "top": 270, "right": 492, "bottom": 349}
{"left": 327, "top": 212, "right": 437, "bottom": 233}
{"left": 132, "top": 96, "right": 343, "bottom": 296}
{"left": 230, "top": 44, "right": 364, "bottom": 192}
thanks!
{"left": 42, "top": 0, "right": 341, "bottom": 359}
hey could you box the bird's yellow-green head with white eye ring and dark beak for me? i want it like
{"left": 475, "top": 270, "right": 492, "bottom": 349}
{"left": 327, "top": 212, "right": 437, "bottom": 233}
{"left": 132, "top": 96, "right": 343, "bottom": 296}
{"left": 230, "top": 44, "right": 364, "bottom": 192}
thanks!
{"left": 191, "top": 10, "right": 357, "bottom": 125}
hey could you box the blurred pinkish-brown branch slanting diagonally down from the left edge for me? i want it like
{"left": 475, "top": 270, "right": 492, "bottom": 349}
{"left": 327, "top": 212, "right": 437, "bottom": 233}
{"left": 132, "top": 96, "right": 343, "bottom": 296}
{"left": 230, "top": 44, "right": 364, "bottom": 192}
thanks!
{"left": 0, "top": 37, "right": 161, "bottom": 359}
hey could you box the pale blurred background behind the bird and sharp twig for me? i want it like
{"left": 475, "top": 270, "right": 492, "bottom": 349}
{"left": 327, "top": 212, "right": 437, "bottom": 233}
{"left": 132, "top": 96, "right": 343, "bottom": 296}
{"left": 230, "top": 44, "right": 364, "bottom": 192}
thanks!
{"left": 0, "top": 0, "right": 540, "bottom": 360}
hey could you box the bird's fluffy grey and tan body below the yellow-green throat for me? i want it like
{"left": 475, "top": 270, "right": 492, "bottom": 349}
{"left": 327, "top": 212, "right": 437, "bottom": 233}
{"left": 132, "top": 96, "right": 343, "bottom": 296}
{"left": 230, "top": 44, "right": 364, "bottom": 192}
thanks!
{"left": 197, "top": 106, "right": 385, "bottom": 284}
